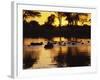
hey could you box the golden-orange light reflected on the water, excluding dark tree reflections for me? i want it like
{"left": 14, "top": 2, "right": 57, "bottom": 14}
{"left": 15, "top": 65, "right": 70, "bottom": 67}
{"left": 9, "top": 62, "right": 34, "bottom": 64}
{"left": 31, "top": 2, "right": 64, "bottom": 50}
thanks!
{"left": 23, "top": 38, "right": 90, "bottom": 68}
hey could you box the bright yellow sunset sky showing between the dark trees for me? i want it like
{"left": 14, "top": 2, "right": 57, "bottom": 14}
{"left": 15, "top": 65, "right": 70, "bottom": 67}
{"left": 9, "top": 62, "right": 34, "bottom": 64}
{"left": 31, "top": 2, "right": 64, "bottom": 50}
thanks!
{"left": 25, "top": 11, "right": 91, "bottom": 26}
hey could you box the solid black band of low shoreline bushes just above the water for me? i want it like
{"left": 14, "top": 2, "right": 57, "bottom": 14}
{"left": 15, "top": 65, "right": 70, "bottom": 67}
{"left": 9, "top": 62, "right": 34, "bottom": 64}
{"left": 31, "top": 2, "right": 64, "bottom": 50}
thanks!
{"left": 23, "top": 21, "right": 91, "bottom": 38}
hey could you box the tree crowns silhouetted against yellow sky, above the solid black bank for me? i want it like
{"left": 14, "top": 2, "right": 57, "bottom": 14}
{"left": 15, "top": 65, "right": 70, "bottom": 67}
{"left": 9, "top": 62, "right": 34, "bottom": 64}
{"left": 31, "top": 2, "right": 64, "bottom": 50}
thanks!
{"left": 23, "top": 10, "right": 91, "bottom": 26}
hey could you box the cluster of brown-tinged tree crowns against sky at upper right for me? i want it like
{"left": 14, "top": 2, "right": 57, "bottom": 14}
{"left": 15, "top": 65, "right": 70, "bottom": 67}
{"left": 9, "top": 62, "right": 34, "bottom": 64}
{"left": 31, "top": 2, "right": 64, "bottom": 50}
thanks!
{"left": 56, "top": 12, "right": 90, "bottom": 26}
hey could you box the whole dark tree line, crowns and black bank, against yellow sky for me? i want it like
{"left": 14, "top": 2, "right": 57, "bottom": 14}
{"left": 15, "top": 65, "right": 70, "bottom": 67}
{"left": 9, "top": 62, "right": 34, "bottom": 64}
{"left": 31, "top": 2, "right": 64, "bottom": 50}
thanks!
{"left": 23, "top": 10, "right": 91, "bottom": 38}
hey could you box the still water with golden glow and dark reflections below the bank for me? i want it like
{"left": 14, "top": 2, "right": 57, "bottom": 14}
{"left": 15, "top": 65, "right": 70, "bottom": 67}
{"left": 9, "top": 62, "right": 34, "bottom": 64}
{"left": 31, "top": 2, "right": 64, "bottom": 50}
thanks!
{"left": 23, "top": 37, "right": 91, "bottom": 69}
